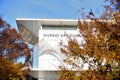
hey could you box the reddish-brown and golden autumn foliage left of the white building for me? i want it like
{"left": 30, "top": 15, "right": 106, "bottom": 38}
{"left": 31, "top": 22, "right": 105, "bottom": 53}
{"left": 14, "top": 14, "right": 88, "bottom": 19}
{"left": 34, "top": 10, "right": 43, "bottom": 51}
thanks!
{"left": 0, "top": 18, "right": 30, "bottom": 80}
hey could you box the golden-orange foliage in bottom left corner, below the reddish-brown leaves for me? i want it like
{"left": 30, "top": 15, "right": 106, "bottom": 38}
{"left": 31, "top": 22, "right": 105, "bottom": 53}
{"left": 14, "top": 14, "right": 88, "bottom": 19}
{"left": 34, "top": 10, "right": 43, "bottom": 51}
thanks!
{"left": 0, "top": 56, "right": 22, "bottom": 80}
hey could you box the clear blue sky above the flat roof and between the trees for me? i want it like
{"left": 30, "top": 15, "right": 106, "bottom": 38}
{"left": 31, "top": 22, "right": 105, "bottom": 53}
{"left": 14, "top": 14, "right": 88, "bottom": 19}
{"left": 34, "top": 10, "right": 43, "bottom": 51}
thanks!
{"left": 0, "top": 0, "right": 103, "bottom": 27}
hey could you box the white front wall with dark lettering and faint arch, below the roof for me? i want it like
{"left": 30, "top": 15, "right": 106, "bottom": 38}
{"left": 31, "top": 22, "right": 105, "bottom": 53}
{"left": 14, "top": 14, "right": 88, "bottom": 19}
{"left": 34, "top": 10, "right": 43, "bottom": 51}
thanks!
{"left": 39, "top": 27, "right": 82, "bottom": 70}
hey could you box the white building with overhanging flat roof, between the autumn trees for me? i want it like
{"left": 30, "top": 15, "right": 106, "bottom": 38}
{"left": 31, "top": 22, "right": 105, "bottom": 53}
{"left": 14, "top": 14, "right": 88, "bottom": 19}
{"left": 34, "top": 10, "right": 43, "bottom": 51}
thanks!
{"left": 16, "top": 18, "right": 81, "bottom": 80}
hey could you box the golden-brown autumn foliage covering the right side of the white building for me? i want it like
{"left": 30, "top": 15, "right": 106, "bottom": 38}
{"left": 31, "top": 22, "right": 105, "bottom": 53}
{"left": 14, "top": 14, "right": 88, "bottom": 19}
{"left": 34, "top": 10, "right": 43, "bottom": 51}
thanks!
{"left": 60, "top": 0, "right": 120, "bottom": 80}
